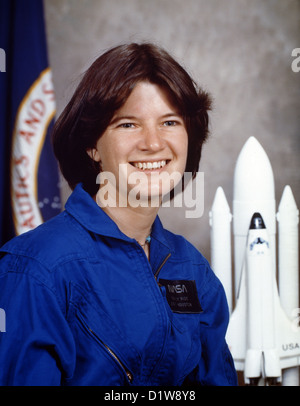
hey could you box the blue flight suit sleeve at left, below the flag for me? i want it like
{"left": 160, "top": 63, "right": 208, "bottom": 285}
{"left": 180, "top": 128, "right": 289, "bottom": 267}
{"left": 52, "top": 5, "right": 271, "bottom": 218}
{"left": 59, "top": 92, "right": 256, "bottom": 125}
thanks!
{"left": 0, "top": 255, "right": 75, "bottom": 386}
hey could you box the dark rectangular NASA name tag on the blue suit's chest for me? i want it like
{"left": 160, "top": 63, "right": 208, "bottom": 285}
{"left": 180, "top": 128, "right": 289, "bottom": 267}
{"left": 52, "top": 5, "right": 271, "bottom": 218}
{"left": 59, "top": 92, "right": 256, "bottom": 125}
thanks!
{"left": 159, "top": 279, "right": 203, "bottom": 313}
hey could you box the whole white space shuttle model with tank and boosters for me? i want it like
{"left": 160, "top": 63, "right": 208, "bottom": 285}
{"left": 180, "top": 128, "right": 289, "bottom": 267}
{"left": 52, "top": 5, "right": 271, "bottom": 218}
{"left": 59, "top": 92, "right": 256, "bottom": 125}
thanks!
{"left": 210, "top": 137, "right": 300, "bottom": 386}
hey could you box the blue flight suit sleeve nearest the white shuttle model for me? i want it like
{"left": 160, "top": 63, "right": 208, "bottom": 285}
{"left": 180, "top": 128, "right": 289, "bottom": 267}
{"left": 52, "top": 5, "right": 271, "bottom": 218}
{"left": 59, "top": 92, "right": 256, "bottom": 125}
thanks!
{"left": 186, "top": 268, "right": 237, "bottom": 386}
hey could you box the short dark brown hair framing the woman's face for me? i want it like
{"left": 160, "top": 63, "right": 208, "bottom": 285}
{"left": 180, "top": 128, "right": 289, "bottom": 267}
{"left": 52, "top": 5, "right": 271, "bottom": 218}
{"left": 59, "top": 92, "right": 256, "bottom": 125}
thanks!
{"left": 53, "top": 43, "right": 211, "bottom": 195}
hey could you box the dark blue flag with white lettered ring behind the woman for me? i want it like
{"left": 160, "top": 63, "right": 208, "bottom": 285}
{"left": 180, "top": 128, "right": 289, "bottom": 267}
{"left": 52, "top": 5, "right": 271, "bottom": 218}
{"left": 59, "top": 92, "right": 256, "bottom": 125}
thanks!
{"left": 0, "top": 0, "right": 61, "bottom": 245}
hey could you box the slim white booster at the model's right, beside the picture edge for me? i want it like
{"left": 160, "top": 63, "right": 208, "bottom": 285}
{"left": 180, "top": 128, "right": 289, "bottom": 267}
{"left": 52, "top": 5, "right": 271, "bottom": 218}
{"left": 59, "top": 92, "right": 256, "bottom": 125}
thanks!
{"left": 277, "top": 185, "right": 299, "bottom": 386}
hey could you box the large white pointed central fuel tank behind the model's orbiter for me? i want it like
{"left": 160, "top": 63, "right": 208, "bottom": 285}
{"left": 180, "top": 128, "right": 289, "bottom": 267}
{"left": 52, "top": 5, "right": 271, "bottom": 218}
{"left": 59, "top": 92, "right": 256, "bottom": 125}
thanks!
{"left": 233, "top": 137, "right": 276, "bottom": 294}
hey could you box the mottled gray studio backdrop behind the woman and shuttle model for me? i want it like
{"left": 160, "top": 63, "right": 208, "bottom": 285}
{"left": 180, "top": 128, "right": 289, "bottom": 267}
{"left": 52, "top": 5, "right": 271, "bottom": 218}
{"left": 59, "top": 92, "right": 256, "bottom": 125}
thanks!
{"left": 45, "top": 0, "right": 300, "bottom": 259}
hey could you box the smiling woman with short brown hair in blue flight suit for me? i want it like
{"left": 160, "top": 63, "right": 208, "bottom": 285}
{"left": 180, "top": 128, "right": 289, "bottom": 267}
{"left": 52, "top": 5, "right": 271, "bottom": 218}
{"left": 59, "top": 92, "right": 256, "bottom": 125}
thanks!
{"left": 0, "top": 44, "right": 237, "bottom": 386}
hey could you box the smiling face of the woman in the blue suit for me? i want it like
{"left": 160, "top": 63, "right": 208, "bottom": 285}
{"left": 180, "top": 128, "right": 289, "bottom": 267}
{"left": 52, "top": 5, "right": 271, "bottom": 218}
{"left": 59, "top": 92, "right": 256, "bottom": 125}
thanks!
{"left": 90, "top": 82, "right": 188, "bottom": 206}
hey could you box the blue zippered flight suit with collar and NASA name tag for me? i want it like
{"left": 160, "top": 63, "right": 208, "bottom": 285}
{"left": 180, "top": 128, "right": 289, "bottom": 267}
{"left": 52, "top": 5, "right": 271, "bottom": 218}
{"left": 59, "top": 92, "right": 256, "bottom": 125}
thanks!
{"left": 0, "top": 185, "right": 237, "bottom": 386}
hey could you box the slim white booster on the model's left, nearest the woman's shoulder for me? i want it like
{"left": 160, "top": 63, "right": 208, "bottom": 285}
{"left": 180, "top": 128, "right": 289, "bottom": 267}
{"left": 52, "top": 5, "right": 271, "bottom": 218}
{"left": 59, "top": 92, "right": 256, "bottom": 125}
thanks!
{"left": 209, "top": 186, "right": 232, "bottom": 313}
